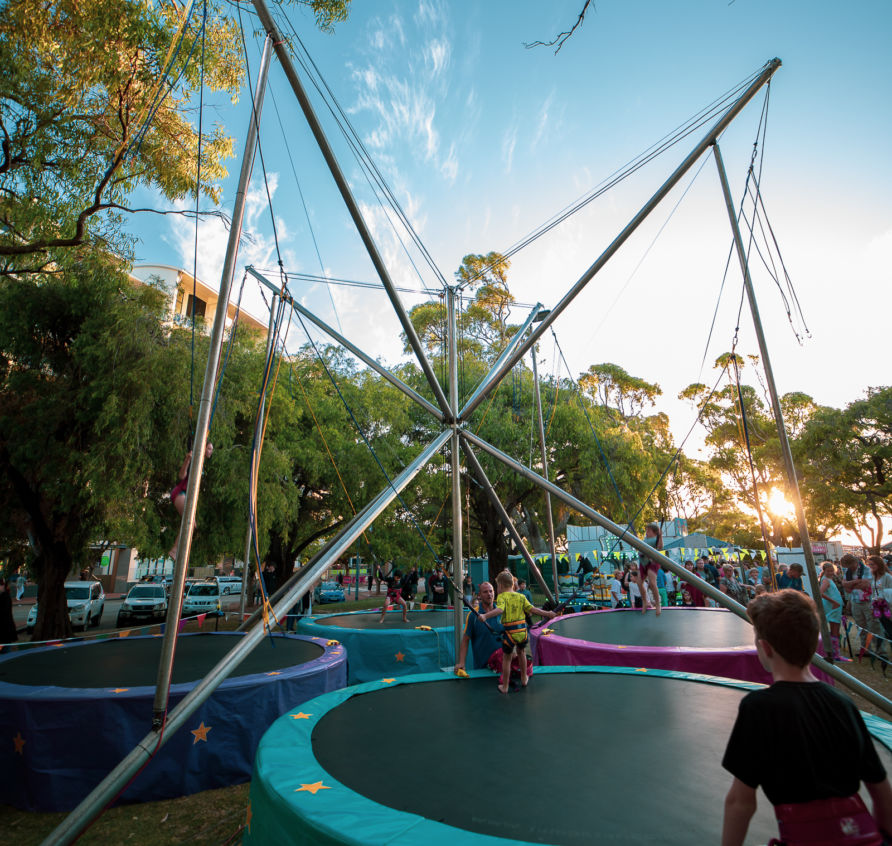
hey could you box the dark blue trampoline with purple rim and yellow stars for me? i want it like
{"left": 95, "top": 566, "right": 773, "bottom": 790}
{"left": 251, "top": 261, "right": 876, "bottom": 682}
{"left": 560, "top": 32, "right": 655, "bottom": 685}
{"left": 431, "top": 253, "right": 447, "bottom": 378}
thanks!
{"left": 0, "top": 632, "right": 347, "bottom": 811}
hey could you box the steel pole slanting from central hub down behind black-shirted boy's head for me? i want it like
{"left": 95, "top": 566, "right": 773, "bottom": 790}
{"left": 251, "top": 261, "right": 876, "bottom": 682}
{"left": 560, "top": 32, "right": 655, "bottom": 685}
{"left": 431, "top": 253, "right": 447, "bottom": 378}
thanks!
{"left": 462, "top": 431, "right": 892, "bottom": 714}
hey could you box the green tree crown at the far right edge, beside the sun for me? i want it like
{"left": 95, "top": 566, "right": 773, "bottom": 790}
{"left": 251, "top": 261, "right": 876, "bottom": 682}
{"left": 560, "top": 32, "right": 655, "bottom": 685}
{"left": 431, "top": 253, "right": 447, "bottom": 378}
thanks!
{"left": 795, "top": 388, "right": 892, "bottom": 552}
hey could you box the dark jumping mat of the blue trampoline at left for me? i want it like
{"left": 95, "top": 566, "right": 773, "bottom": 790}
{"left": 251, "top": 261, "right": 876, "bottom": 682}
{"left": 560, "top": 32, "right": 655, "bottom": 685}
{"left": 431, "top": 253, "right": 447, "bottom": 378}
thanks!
{"left": 0, "top": 634, "right": 325, "bottom": 688}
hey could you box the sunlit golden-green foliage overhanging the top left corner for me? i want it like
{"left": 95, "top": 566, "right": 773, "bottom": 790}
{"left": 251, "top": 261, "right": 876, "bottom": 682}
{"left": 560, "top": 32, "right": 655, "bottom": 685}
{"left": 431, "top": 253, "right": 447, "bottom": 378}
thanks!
{"left": 0, "top": 0, "right": 349, "bottom": 274}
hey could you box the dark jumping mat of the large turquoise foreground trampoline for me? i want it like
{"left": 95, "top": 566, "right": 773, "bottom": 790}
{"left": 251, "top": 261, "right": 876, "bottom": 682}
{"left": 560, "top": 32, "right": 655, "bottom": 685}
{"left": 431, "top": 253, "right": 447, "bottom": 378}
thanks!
{"left": 312, "top": 673, "right": 788, "bottom": 846}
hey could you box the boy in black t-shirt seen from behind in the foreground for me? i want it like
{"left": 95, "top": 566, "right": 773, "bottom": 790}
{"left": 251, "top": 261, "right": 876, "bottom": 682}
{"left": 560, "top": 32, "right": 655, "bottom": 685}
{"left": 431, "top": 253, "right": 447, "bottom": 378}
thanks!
{"left": 722, "top": 590, "right": 892, "bottom": 846}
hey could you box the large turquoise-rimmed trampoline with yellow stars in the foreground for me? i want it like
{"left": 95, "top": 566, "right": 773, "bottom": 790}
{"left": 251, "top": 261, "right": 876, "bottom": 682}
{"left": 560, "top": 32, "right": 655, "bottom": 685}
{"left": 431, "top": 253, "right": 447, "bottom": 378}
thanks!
{"left": 243, "top": 667, "right": 892, "bottom": 846}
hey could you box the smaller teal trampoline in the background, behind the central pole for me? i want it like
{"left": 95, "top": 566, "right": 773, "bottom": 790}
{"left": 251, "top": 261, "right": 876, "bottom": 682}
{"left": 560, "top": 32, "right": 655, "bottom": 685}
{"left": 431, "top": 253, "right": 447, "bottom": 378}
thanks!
{"left": 297, "top": 608, "right": 455, "bottom": 684}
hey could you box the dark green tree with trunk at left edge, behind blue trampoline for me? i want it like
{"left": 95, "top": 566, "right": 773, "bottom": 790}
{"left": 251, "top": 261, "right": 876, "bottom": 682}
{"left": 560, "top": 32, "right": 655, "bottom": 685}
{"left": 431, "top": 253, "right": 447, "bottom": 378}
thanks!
{"left": 0, "top": 255, "right": 181, "bottom": 637}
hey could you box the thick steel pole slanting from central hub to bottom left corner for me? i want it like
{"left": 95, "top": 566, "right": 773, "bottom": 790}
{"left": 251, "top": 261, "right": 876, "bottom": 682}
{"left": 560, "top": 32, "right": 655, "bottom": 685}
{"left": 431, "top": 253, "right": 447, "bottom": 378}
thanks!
{"left": 44, "top": 430, "right": 450, "bottom": 846}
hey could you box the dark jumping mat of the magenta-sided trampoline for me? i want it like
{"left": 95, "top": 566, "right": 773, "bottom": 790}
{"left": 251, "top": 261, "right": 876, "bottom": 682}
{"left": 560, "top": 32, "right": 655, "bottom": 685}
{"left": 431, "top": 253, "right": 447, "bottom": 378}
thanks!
{"left": 548, "top": 608, "right": 753, "bottom": 649}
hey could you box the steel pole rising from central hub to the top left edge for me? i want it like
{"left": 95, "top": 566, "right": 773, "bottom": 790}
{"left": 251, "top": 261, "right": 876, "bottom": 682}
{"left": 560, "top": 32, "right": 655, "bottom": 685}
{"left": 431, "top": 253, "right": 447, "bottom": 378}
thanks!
{"left": 247, "top": 0, "right": 449, "bottom": 414}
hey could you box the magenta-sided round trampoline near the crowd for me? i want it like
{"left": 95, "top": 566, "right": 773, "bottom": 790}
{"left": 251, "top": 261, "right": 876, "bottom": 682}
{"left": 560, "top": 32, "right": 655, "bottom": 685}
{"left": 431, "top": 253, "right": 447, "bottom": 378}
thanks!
{"left": 531, "top": 608, "right": 771, "bottom": 684}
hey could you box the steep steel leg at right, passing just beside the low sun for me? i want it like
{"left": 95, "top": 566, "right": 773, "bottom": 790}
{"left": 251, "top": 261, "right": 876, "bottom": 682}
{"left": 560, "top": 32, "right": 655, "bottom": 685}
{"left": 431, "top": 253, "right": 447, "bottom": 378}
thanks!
{"left": 712, "top": 142, "right": 833, "bottom": 663}
